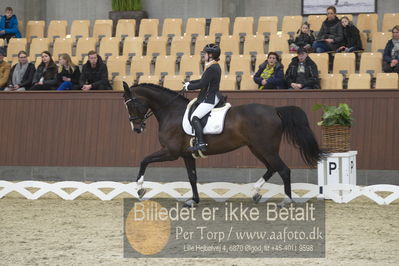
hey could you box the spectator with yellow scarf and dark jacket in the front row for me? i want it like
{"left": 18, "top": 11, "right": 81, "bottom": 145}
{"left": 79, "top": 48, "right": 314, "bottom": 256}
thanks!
{"left": 254, "top": 52, "right": 285, "bottom": 90}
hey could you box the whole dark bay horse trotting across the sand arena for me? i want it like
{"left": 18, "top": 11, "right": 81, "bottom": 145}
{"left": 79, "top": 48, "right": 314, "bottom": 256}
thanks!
{"left": 123, "top": 83, "right": 325, "bottom": 206}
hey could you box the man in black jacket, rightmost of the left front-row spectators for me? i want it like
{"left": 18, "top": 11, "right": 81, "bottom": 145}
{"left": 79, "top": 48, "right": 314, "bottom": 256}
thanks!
{"left": 80, "top": 51, "right": 112, "bottom": 91}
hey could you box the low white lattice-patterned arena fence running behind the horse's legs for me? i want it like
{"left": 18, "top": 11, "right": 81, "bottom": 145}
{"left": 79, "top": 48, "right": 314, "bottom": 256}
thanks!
{"left": 0, "top": 181, "right": 399, "bottom": 204}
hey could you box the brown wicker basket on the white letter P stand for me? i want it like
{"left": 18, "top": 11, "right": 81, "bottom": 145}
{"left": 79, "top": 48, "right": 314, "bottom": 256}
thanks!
{"left": 321, "top": 125, "right": 351, "bottom": 152}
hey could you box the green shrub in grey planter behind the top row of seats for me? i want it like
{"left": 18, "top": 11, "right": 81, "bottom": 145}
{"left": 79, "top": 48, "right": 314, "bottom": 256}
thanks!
{"left": 109, "top": 0, "right": 148, "bottom": 35}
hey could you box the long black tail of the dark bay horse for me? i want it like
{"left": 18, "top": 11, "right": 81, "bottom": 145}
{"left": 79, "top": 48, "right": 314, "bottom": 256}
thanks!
{"left": 276, "top": 106, "right": 326, "bottom": 167}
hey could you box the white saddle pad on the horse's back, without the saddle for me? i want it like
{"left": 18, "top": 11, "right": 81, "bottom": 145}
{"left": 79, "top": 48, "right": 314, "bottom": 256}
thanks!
{"left": 182, "top": 98, "right": 231, "bottom": 136}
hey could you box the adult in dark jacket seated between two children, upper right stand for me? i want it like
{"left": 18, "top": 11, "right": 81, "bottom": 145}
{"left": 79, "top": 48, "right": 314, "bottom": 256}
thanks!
{"left": 313, "top": 6, "right": 344, "bottom": 53}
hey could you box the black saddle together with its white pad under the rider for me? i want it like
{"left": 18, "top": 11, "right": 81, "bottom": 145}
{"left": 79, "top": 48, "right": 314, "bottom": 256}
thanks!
{"left": 182, "top": 97, "right": 231, "bottom": 136}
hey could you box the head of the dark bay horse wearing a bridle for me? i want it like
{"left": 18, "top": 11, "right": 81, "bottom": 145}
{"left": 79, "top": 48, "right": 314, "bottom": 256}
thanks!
{"left": 123, "top": 82, "right": 149, "bottom": 133}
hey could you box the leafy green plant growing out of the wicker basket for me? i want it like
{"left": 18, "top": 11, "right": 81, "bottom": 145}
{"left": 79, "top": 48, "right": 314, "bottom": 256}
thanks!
{"left": 313, "top": 103, "right": 353, "bottom": 126}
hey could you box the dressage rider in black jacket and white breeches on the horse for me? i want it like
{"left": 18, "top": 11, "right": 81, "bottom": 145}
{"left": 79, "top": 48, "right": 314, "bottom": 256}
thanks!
{"left": 184, "top": 43, "right": 222, "bottom": 152}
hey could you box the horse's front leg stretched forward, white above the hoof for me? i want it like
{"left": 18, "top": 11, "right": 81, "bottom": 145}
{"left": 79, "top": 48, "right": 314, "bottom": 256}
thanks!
{"left": 136, "top": 148, "right": 178, "bottom": 199}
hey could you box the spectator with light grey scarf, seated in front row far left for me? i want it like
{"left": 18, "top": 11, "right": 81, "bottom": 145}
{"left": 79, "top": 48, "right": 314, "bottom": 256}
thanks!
{"left": 4, "top": 51, "right": 35, "bottom": 91}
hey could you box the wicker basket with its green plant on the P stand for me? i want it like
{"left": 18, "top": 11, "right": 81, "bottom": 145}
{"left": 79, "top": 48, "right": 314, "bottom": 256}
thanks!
{"left": 313, "top": 103, "right": 353, "bottom": 152}
